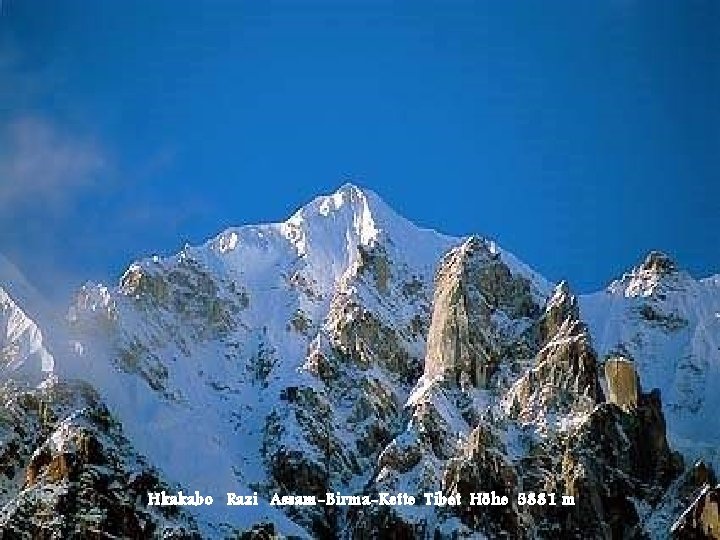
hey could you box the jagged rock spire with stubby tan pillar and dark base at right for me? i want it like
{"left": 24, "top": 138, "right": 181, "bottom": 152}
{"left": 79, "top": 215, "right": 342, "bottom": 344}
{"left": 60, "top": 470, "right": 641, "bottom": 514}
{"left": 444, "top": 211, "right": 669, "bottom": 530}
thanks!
{"left": 498, "top": 283, "right": 681, "bottom": 539}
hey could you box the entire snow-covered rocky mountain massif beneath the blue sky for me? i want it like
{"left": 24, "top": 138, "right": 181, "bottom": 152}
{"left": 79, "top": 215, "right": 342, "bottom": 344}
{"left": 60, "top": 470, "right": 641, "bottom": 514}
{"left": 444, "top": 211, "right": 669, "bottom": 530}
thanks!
{"left": 0, "top": 185, "right": 720, "bottom": 538}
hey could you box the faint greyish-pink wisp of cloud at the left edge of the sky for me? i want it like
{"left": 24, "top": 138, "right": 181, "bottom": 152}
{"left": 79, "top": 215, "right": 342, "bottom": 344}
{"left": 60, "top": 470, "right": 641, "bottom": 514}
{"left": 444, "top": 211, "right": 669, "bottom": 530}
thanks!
{"left": 0, "top": 116, "right": 108, "bottom": 207}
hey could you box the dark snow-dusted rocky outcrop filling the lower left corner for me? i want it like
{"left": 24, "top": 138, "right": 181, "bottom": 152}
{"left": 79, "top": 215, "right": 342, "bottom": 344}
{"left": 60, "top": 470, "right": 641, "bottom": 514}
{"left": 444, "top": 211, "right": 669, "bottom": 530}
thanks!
{"left": 0, "top": 383, "right": 200, "bottom": 539}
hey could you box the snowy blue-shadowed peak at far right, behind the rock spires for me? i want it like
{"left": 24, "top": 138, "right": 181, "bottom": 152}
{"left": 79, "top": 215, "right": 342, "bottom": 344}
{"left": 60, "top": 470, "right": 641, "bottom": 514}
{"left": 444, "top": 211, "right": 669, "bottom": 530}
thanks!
{"left": 580, "top": 254, "right": 720, "bottom": 470}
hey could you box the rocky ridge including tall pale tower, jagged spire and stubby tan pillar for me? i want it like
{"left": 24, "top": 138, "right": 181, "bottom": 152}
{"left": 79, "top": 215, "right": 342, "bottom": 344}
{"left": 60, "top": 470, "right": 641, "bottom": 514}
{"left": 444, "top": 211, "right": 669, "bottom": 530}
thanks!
{"left": 351, "top": 248, "right": 681, "bottom": 540}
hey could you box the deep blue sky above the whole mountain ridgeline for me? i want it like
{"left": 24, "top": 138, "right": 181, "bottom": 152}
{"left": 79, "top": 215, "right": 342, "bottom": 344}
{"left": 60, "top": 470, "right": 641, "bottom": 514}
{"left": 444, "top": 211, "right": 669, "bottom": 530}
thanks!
{"left": 0, "top": 0, "right": 720, "bottom": 295}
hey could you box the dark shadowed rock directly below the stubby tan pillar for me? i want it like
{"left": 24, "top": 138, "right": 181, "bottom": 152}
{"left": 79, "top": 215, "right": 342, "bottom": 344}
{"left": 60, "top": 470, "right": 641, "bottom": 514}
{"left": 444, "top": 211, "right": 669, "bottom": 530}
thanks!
{"left": 548, "top": 386, "right": 682, "bottom": 539}
